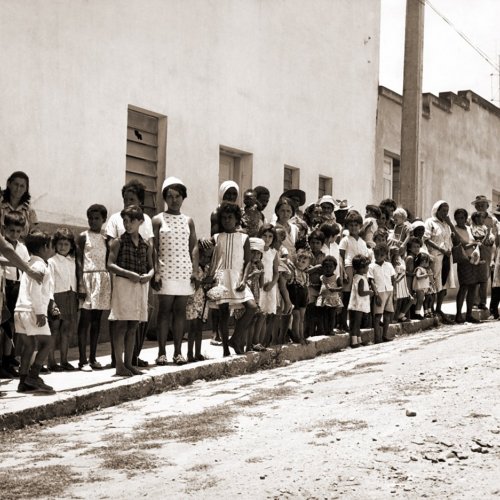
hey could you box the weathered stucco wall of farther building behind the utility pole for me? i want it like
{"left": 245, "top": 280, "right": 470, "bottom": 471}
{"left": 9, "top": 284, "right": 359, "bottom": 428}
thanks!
{"left": 376, "top": 89, "right": 500, "bottom": 218}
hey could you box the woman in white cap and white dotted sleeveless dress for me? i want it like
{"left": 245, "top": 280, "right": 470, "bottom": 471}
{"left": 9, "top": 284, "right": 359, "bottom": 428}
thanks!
{"left": 153, "top": 177, "right": 198, "bottom": 365}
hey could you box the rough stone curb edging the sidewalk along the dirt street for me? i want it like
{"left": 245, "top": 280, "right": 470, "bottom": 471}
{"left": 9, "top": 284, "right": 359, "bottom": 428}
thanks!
{"left": 0, "top": 318, "right": 439, "bottom": 431}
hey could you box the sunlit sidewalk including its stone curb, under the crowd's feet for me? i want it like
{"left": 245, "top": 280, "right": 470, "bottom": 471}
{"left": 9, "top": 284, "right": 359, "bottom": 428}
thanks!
{"left": 0, "top": 298, "right": 492, "bottom": 430}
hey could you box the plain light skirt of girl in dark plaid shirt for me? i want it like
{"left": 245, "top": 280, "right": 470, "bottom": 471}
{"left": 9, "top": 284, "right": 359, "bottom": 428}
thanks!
{"left": 109, "top": 276, "right": 149, "bottom": 322}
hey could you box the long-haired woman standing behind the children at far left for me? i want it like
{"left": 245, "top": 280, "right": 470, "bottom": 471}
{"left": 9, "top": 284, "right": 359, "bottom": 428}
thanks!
{"left": 0, "top": 171, "right": 38, "bottom": 236}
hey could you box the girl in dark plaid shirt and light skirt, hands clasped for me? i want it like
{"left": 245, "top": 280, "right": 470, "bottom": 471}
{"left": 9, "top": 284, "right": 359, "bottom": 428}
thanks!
{"left": 108, "top": 205, "right": 154, "bottom": 377}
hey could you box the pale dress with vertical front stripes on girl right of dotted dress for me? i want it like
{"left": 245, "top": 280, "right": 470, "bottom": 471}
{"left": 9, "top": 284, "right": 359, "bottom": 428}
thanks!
{"left": 212, "top": 233, "right": 254, "bottom": 306}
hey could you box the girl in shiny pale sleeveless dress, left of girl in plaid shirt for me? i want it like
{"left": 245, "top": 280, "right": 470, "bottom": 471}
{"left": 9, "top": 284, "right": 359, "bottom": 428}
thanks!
{"left": 76, "top": 204, "right": 111, "bottom": 371}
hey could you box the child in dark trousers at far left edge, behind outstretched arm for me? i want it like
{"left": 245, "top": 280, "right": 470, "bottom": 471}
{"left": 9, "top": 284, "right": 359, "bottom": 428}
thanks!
{"left": 0, "top": 211, "right": 30, "bottom": 377}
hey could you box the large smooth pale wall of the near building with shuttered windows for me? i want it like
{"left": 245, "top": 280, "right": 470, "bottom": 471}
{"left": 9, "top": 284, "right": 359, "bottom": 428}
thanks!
{"left": 0, "top": 0, "right": 380, "bottom": 234}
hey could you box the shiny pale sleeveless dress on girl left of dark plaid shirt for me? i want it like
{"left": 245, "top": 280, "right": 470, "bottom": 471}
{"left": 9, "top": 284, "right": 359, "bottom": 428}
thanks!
{"left": 80, "top": 230, "right": 111, "bottom": 311}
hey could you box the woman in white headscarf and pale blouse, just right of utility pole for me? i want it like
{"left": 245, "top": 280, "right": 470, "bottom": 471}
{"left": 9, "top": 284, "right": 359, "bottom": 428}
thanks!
{"left": 424, "top": 200, "right": 455, "bottom": 324}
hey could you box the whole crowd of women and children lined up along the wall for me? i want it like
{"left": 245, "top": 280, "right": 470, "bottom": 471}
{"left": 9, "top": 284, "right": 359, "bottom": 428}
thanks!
{"left": 0, "top": 172, "right": 500, "bottom": 393}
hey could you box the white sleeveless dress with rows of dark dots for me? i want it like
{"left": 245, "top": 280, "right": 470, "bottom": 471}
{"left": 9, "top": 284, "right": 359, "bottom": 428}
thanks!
{"left": 156, "top": 212, "right": 194, "bottom": 295}
